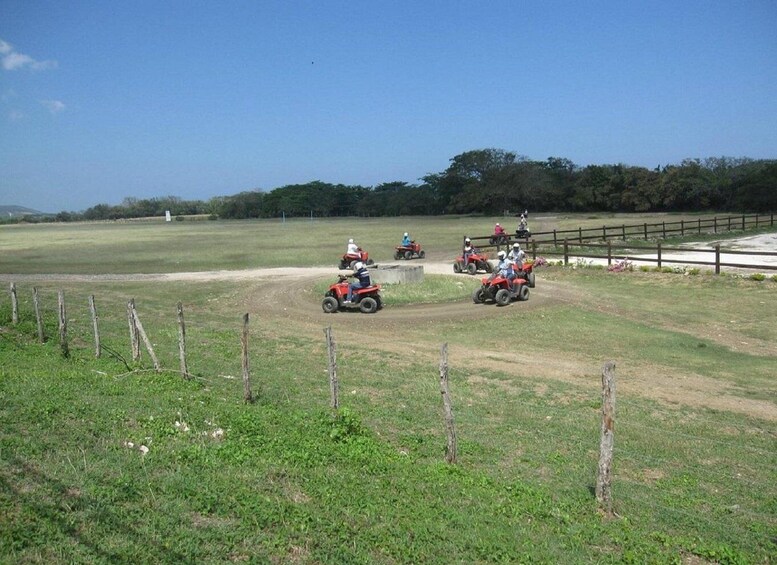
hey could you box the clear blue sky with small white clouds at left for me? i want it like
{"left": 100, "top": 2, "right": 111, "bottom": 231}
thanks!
{"left": 0, "top": 0, "right": 777, "bottom": 212}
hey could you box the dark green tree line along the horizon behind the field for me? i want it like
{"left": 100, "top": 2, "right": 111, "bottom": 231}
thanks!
{"left": 13, "top": 149, "right": 777, "bottom": 221}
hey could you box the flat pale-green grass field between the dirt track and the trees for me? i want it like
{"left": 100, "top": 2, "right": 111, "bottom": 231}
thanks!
{"left": 0, "top": 210, "right": 756, "bottom": 274}
